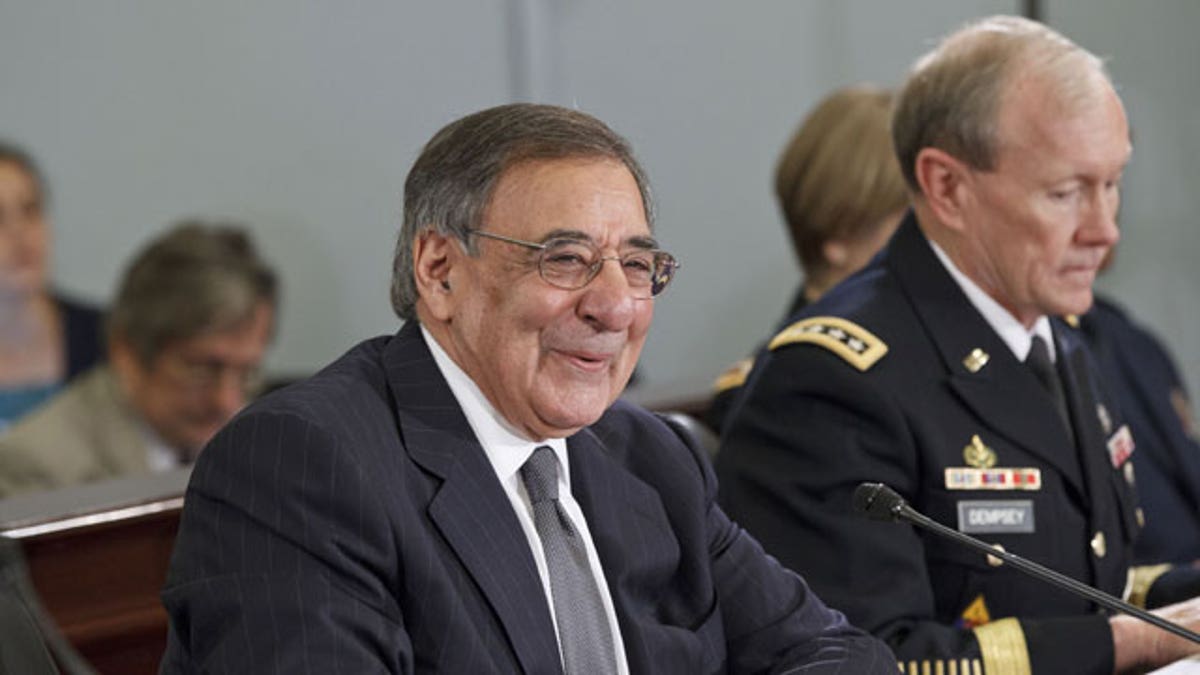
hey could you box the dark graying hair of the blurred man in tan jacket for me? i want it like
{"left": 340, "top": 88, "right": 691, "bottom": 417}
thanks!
{"left": 108, "top": 220, "right": 278, "bottom": 366}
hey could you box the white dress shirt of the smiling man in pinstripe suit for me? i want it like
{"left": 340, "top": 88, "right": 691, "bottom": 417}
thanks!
{"left": 421, "top": 325, "right": 629, "bottom": 675}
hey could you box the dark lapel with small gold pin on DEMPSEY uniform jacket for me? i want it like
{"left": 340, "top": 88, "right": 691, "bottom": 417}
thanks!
{"left": 887, "top": 218, "right": 1085, "bottom": 497}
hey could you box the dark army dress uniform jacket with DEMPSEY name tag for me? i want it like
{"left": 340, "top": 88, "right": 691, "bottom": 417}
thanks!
{"left": 718, "top": 213, "right": 1156, "bottom": 675}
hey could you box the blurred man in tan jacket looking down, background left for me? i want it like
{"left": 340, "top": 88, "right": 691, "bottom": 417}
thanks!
{"left": 0, "top": 221, "right": 277, "bottom": 497}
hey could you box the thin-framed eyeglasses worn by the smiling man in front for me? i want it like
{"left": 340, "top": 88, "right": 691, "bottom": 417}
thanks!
{"left": 468, "top": 229, "right": 679, "bottom": 300}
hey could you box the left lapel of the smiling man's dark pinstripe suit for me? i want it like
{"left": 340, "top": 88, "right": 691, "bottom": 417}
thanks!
{"left": 383, "top": 321, "right": 560, "bottom": 673}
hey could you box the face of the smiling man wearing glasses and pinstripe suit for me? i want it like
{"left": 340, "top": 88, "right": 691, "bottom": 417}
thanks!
{"left": 418, "top": 159, "right": 654, "bottom": 440}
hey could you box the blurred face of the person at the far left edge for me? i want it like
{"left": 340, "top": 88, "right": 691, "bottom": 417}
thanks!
{"left": 0, "top": 161, "right": 49, "bottom": 295}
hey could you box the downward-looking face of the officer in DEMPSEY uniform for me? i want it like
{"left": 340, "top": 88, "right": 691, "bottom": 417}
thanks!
{"left": 959, "top": 74, "right": 1130, "bottom": 325}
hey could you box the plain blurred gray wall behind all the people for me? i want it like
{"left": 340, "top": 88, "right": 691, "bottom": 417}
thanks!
{"left": 0, "top": 0, "right": 1200, "bottom": 398}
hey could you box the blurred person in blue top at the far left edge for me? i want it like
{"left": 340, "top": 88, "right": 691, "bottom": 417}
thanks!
{"left": 0, "top": 141, "right": 102, "bottom": 432}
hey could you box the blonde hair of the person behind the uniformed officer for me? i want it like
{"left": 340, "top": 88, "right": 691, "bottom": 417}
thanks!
{"left": 775, "top": 85, "right": 908, "bottom": 274}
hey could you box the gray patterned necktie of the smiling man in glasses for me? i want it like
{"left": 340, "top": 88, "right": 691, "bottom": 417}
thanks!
{"left": 521, "top": 446, "right": 617, "bottom": 675}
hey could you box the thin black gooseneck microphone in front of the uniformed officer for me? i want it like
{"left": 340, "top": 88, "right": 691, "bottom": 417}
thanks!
{"left": 851, "top": 483, "right": 1200, "bottom": 644}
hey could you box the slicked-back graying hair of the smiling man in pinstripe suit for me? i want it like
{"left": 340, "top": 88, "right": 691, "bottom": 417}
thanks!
{"left": 391, "top": 103, "right": 654, "bottom": 321}
